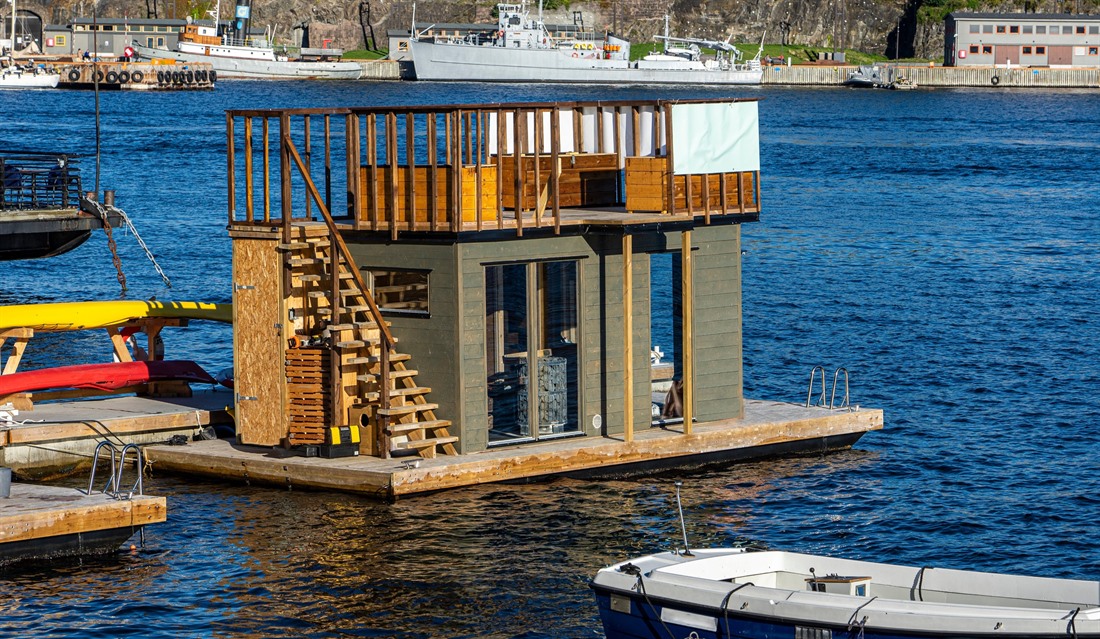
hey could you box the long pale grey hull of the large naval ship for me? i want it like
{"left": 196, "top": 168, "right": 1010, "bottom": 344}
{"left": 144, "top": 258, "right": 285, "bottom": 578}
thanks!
{"left": 409, "top": 41, "right": 763, "bottom": 85}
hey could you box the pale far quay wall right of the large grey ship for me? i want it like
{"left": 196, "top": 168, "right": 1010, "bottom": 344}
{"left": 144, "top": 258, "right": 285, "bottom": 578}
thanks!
{"left": 763, "top": 65, "right": 1100, "bottom": 88}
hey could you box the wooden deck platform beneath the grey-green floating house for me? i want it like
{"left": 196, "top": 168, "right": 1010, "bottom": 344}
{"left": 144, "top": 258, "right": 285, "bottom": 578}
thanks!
{"left": 145, "top": 400, "right": 883, "bottom": 499}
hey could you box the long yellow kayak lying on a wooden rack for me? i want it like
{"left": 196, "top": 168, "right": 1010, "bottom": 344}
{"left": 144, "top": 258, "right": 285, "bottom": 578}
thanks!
{"left": 0, "top": 301, "right": 233, "bottom": 331}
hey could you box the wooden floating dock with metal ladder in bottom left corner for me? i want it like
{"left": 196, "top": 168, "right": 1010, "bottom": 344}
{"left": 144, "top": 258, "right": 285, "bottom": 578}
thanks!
{"left": 0, "top": 482, "right": 167, "bottom": 566}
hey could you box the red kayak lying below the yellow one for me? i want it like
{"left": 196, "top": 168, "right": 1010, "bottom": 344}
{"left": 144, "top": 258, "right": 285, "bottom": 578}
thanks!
{"left": 0, "top": 361, "right": 215, "bottom": 396}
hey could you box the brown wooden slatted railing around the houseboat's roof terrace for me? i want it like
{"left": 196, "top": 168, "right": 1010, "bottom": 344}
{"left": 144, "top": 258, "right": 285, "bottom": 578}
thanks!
{"left": 226, "top": 99, "right": 760, "bottom": 240}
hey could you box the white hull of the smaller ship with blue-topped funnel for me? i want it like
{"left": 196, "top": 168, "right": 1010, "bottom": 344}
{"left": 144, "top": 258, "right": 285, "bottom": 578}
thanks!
{"left": 133, "top": 43, "right": 363, "bottom": 80}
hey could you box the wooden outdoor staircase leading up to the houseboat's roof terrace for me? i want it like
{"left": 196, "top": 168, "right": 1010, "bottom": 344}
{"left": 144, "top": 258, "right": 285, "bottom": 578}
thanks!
{"left": 278, "top": 222, "right": 458, "bottom": 458}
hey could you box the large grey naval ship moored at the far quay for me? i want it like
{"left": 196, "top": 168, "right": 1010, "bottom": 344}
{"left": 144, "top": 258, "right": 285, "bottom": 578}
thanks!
{"left": 409, "top": 2, "right": 763, "bottom": 85}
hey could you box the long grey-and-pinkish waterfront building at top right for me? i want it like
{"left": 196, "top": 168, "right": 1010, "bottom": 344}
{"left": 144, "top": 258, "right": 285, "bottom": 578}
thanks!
{"left": 944, "top": 12, "right": 1100, "bottom": 67}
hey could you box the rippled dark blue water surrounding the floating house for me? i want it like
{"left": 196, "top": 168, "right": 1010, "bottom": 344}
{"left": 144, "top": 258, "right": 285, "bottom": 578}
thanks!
{"left": 0, "top": 81, "right": 1100, "bottom": 639}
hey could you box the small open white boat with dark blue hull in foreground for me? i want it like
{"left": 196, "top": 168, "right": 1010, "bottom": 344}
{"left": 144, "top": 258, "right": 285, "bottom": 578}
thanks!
{"left": 591, "top": 549, "right": 1100, "bottom": 639}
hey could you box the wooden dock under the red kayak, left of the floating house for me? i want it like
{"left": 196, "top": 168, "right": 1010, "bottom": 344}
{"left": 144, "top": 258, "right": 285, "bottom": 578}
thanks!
{"left": 0, "top": 390, "right": 233, "bottom": 476}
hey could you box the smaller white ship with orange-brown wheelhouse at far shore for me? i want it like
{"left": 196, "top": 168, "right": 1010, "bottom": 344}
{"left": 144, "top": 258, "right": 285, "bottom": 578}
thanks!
{"left": 131, "top": 0, "right": 363, "bottom": 80}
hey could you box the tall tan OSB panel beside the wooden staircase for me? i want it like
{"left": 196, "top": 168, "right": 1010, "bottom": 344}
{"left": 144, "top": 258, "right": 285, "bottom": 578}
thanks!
{"left": 233, "top": 239, "right": 287, "bottom": 445}
